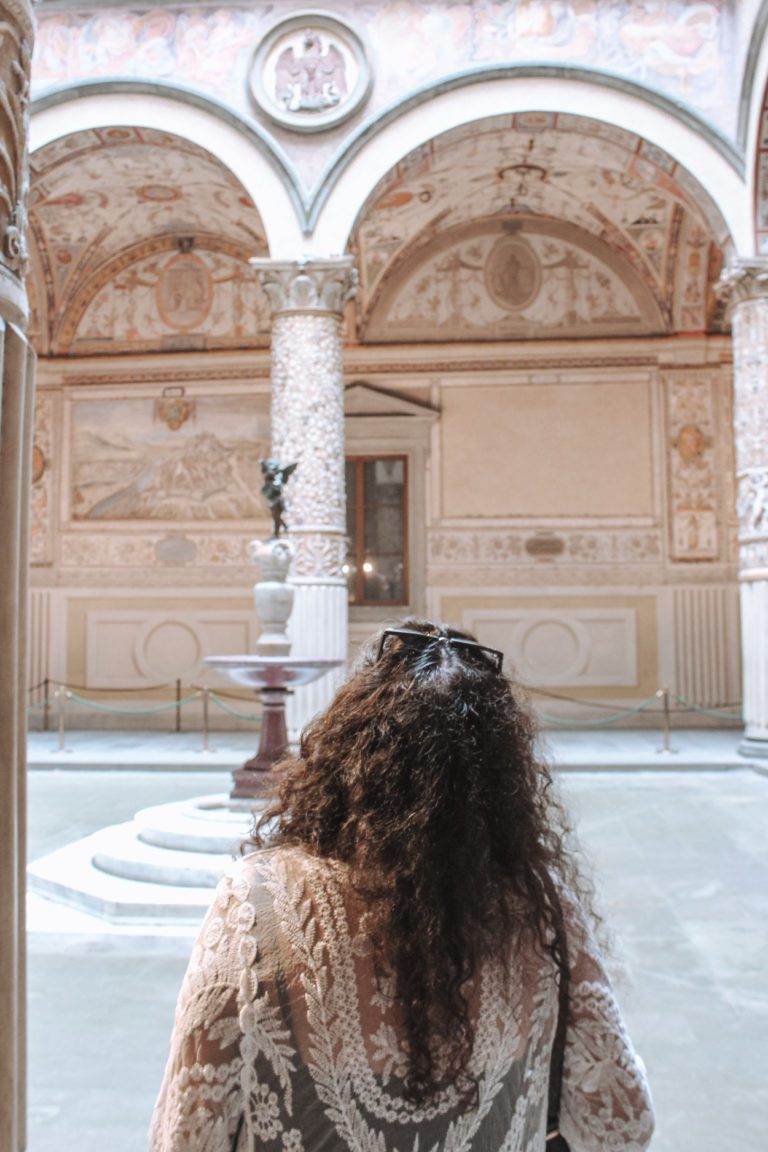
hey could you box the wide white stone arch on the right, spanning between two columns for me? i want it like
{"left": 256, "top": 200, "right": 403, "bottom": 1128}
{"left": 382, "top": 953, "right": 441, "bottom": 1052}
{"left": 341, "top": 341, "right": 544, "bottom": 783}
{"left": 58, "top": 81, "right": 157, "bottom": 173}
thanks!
{"left": 310, "top": 66, "right": 752, "bottom": 253}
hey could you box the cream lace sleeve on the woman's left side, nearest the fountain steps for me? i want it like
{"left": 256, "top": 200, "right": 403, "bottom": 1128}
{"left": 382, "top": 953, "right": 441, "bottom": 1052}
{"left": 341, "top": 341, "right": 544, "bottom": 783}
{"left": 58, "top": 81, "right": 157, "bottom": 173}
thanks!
{"left": 150, "top": 877, "right": 249, "bottom": 1152}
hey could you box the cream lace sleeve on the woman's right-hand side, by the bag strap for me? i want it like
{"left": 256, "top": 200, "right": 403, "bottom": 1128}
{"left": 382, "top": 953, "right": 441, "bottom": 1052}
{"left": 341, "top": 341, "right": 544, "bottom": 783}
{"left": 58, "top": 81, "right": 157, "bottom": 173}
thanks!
{"left": 560, "top": 898, "right": 654, "bottom": 1152}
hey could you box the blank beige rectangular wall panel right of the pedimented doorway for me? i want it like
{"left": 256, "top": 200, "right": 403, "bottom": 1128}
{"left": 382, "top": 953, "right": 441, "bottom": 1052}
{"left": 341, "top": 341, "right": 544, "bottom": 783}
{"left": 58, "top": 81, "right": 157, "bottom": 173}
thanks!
{"left": 441, "top": 381, "right": 653, "bottom": 517}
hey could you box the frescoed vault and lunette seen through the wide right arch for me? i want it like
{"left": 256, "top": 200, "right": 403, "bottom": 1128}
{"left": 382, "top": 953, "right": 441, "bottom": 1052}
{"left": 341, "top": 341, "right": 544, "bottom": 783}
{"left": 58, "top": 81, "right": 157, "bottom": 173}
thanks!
{"left": 352, "top": 113, "right": 729, "bottom": 340}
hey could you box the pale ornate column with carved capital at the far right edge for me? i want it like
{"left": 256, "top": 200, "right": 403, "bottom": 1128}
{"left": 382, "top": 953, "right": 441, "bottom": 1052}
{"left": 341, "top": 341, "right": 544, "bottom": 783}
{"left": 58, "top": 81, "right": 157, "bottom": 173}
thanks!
{"left": 721, "top": 258, "right": 768, "bottom": 757}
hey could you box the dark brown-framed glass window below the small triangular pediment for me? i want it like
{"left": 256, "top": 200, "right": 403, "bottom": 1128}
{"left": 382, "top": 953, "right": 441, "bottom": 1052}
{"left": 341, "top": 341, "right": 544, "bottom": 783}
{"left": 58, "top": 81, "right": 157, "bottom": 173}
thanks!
{"left": 344, "top": 456, "right": 408, "bottom": 605}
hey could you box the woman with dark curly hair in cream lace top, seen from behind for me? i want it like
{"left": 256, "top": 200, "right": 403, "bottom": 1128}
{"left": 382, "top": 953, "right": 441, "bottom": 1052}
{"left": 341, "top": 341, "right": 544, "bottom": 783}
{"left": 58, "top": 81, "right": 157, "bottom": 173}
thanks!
{"left": 151, "top": 620, "right": 653, "bottom": 1152}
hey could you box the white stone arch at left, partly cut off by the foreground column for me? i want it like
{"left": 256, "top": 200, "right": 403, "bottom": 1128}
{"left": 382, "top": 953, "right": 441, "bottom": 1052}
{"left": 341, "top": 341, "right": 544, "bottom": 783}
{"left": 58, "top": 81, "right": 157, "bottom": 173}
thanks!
{"left": 30, "top": 81, "right": 304, "bottom": 259}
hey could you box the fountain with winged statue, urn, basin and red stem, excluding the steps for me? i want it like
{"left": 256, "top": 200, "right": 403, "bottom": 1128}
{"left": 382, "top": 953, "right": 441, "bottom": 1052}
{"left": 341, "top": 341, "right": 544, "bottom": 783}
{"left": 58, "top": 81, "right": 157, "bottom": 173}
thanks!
{"left": 205, "top": 460, "right": 342, "bottom": 801}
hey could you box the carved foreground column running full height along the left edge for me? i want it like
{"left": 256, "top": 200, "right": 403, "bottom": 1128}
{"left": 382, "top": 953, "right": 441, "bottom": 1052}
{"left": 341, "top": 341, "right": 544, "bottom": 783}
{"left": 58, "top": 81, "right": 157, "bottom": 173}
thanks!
{"left": 0, "top": 0, "right": 33, "bottom": 1152}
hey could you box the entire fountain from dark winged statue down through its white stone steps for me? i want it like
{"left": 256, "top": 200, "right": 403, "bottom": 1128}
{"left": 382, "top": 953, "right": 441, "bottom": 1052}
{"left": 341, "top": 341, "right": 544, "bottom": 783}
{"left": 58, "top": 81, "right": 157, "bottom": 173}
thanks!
{"left": 29, "top": 460, "right": 342, "bottom": 924}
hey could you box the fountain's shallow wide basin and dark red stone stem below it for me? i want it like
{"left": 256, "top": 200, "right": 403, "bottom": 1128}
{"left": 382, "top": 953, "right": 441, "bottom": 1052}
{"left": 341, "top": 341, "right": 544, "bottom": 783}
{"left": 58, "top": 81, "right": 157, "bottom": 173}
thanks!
{"left": 205, "top": 655, "right": 343, "bottom": 799}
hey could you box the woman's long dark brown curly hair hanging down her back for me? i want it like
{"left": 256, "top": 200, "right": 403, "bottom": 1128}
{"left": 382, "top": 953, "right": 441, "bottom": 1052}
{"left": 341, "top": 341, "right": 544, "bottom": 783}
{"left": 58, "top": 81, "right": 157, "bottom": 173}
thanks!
{"left": 250, "top": 619, "right": 594, "bottom": 1105}
